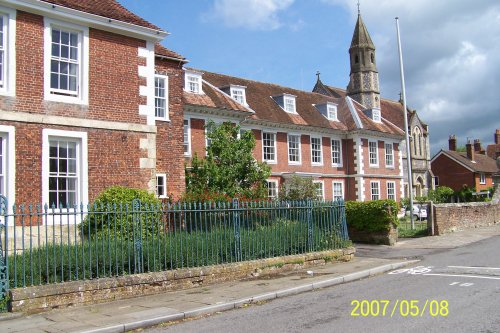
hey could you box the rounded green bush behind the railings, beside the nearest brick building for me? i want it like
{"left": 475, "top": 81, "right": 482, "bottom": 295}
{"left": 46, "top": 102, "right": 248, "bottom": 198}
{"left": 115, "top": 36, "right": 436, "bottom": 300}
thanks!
{"left": 79, "top": 186, "right": 161, "bottom": 239}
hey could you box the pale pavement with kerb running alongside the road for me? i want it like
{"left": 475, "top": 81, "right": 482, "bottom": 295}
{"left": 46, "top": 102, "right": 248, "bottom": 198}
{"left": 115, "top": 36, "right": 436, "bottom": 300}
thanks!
{"left": 0, "top": 225, "right": 500, "bottom": 333}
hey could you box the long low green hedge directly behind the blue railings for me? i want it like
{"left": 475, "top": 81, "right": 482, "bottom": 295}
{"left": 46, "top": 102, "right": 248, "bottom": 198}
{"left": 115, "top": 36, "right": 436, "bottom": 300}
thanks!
{"left": 9, "top": 218, "right": 350, "bottom": 288}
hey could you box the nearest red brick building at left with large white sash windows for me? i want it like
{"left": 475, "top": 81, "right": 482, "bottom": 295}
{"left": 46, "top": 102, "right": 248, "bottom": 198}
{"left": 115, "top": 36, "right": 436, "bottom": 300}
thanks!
{"left": 0, "top": 0, "right": 185, "bottom": 206}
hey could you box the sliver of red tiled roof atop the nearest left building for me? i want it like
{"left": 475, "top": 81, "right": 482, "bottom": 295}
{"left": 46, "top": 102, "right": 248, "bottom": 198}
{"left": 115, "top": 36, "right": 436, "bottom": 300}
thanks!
{"left": 42, "top": 0, "right": 162, "bottom": 30}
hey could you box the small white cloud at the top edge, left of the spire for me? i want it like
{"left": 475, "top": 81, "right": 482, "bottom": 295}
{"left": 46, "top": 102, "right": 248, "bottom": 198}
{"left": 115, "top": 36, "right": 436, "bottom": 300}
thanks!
{"left": 206, "top": 0, "right": 294, "bottom": 30}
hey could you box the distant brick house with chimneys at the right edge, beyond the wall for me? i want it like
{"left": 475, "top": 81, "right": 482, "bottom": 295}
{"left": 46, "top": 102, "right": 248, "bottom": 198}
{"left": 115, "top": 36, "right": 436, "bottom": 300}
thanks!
{"left": 431, "top": 135, "right": 498, "bottom": 191}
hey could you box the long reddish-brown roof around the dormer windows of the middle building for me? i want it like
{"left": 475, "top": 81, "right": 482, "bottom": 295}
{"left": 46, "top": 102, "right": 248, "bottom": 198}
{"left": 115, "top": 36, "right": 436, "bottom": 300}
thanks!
{"left": 184, "top": 70, "right": 403, "bottom": 135}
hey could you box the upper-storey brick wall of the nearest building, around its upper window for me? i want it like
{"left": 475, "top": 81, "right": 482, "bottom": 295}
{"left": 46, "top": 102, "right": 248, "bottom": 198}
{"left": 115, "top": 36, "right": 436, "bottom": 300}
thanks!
{"left": 0, "top": 11, "right": 146, "bottom": 124}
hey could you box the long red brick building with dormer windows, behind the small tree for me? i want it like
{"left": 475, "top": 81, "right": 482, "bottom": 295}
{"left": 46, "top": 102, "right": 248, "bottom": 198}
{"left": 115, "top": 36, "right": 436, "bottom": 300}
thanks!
{"left": 184, "top": 69, "right": 403, "bottom": 200}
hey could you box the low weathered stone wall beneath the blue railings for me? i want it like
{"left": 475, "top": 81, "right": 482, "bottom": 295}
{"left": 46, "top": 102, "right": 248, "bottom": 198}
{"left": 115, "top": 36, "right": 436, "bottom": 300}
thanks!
{"left": 9, "top": 247, "right": 355, "bottom": 313}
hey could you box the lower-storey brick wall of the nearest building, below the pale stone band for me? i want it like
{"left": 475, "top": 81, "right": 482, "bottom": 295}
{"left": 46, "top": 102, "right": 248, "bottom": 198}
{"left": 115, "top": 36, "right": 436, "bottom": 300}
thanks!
{"left": 9, "top": 123, "right": 151, "bottom": 204}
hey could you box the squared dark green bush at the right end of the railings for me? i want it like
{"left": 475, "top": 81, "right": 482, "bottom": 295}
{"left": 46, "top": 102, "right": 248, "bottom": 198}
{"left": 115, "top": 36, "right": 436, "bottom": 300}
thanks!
{"left": 346, "top": 200, "right": 399, "bottom": 232}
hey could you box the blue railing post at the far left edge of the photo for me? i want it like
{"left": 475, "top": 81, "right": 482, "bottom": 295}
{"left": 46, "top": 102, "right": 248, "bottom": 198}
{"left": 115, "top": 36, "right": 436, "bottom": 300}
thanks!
{"left": 0, "top": 195, "right": 9, "bottom": 312}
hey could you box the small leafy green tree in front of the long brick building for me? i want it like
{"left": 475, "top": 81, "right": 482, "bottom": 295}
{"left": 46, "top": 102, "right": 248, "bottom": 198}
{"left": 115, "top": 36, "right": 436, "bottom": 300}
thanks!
{"left": 186, "top": 121, "right": 271, "bottom": 200}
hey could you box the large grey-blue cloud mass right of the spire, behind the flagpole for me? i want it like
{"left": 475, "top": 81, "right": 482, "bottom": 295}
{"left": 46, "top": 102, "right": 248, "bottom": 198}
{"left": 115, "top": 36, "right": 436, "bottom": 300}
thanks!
{"left": 322, "top": 0, "right": 500, "bottom": 152}
